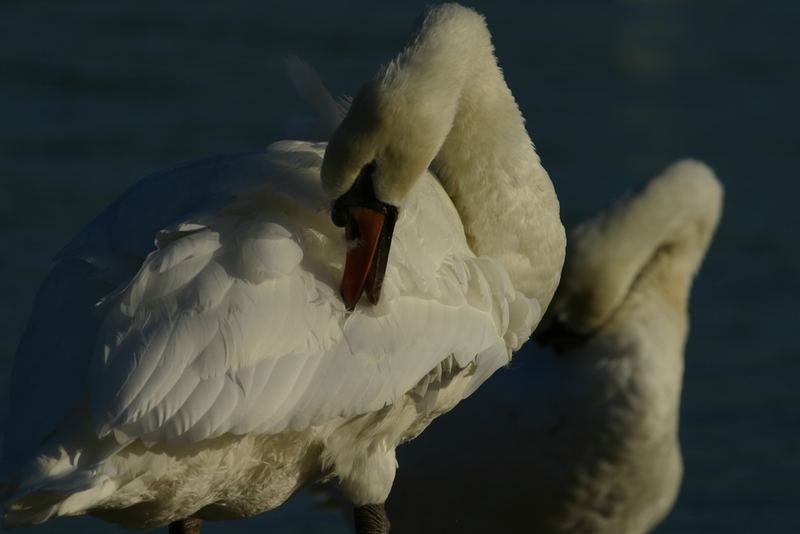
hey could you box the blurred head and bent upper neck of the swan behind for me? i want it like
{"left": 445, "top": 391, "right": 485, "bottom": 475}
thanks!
{"left": 537, "top": 160, "right": 723, "bottom": 352}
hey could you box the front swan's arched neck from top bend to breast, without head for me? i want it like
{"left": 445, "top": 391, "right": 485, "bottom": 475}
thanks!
{"left": 378, "top": 4, "right": 565, "bottom": 309}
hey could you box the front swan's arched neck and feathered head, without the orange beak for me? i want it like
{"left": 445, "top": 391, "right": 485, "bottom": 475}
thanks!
{"left": 322, "top": 4, "right": 565, "bottom": 309}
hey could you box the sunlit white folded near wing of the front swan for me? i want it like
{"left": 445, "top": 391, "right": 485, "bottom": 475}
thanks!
{"left": 90, "top": 161, "right": 538, "bottom": 442}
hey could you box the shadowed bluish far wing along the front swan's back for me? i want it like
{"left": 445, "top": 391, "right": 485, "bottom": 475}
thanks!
{"left": 2, "top": 143, "right": 327, "bottom": 462}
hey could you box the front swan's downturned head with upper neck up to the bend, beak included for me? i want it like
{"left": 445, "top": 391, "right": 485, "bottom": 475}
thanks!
{"left": 322, "top": 4, "right": 484, "bottom": 309}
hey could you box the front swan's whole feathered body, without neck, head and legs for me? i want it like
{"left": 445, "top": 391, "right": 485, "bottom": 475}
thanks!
{"left": 0, "top": 142, "right": 539, "bottom": 527}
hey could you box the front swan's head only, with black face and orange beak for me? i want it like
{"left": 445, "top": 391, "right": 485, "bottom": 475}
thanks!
{"left": 322, "top": 84, "right": 435, "bottom": 310}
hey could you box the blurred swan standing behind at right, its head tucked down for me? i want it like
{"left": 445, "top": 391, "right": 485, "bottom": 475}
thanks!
{"left": 387, "top": 160, "right": 723, "bottom": 534}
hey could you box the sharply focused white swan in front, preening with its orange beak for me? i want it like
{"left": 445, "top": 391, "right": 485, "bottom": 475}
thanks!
{"left": 0, "top": 4, "right": 565, "bottom": 533}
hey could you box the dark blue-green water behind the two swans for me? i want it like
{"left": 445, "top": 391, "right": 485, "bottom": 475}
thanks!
{"left": 0, "top": 0, "right": 800, "bottom": 534}
